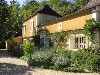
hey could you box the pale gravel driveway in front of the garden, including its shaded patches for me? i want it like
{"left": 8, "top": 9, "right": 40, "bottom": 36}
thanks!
{"left": 0, "top": 51, "right": 100, "bottom": 75}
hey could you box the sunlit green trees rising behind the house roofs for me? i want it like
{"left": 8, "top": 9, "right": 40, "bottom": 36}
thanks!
{"left": 20, "top": 0, "right": 88, "bottom": 20}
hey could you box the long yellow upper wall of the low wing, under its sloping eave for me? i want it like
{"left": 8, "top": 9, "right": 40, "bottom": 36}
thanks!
{"left": 40, "top": 11, "right": 92, "bottom": 33}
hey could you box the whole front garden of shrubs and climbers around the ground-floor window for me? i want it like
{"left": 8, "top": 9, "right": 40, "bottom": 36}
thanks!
{"left": 9, "top": 19, "right": 100, "bottom": 73}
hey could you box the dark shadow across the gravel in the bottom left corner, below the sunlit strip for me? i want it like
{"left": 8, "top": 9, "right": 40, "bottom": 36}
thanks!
{"left": 0, "top": 63, "right": 32, "bottom": 75}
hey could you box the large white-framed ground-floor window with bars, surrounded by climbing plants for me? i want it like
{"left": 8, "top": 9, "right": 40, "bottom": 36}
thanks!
{"left": 68, "top": 34, "right": 88, "bottom": 51}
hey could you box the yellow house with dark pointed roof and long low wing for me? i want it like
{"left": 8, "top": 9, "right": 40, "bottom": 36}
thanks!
{"left": 22, "top": 0, "right": 100, "bottom": 50}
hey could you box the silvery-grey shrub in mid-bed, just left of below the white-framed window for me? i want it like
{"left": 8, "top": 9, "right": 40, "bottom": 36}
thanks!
{"left": 52, "top": 51, "right": 71, "bottom": 67}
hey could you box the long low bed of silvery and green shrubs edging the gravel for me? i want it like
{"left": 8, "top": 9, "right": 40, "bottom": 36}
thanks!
{"left": 22, "top": 48, "right": 100, "bottom": 72}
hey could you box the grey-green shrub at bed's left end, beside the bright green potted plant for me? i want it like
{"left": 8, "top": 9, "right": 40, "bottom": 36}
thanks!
{"left": 32, "top": 50, "right": 54, "bottom": 68}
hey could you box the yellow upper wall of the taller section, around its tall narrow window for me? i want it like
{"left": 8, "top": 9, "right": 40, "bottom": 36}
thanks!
{"left": 22, "top": 16, "right": 36, "bottom": 38}
